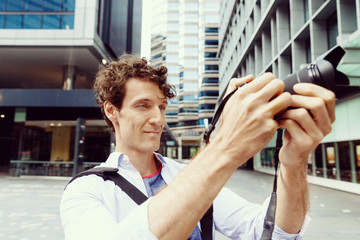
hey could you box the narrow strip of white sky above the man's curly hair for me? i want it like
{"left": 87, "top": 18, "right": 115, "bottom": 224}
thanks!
{"left": 140, "top": 0, "right": 152, "bottom": 59}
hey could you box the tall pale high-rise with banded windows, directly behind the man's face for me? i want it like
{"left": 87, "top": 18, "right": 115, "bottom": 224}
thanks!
{"left": 151, "top": 0, "right": 219, "bottom": 159}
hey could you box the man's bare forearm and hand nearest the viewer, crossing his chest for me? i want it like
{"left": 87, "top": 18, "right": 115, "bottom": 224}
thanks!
{"left": 148, "top": 73, "right": 291, "bottom": 239}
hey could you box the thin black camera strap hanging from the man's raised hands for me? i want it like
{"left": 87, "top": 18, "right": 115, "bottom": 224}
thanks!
{"left": 203, "top": 86, "right": 283, "bottom": 240}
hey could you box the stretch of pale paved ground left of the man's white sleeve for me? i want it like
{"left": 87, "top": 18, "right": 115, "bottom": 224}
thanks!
{"left": 0, "top": 176, "right": 68, "bottom": 240}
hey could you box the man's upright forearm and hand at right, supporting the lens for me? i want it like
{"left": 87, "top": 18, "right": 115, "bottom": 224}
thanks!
{"left": 276, "top": 84, "right": 335, "bottom": 233}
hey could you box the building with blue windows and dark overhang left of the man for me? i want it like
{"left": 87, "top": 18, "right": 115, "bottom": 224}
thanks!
{"left": 0, "top": 0, "right": 142, "bottom": 175}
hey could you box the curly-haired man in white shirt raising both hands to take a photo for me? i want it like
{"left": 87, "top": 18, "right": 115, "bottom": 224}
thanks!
{"left": 61, "top": 55, "right": 335, "bottom": 240}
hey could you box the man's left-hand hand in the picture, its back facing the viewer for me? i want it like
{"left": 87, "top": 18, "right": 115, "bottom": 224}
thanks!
{"left": 214, "top": 73, "right": 291, "bottom": 165}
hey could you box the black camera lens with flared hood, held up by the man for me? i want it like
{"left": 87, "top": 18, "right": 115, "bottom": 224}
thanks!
{"left": 283, "top": 46, "right": 360, "bottom": 100}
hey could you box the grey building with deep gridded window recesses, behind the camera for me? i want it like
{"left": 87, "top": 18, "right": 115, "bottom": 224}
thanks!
{"left": 218, "top": 0, "right": 360, "bottom": 193}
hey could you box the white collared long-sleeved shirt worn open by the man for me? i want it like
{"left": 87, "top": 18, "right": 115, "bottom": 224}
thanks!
{"left": 60, "top": 152, "right": 309, "bottom": 240}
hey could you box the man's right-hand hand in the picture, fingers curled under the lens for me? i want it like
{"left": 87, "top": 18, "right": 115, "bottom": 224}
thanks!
{"left": 279, "top": 83, "right": 335, "bottom": 168}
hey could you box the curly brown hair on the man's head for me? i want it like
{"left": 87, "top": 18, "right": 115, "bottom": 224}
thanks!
{"left": 94, "top": 54, "right": 175, "bottom": 132}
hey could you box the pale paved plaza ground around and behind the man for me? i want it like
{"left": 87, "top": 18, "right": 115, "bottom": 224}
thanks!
{"left": 0, "top": 170, "right": 360, "bottom": 240}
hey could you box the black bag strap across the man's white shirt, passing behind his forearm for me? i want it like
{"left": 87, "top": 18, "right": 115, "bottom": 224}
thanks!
{"left": 65, "top": 167, "right": 213, "bottom": 240}
